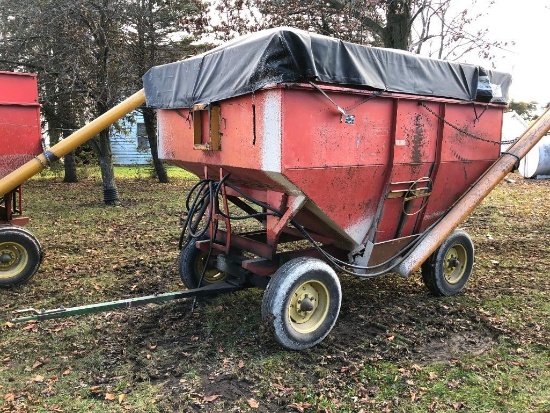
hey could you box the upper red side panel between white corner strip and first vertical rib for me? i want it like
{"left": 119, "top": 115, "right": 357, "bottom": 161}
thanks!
{"left": 283, "top": 88, "right": 393, "bottom": 170}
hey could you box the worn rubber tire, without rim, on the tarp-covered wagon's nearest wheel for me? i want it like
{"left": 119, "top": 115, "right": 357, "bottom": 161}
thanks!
{"left": 262, "top": 257, "right": 342, "bottom": 350}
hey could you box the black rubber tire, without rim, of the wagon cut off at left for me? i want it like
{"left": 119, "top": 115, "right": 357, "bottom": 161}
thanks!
{"left": 0, "top": 225, "right": 44, "bottom": 288}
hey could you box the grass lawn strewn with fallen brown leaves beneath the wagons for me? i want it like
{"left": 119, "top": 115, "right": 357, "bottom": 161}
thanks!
{"left": 0, "top": 168, "right": 550, "bottom": 413}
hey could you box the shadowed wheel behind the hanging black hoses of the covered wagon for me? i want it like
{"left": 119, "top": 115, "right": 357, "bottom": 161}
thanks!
{"left": 178, "top": 241, "right": 228, "bottom": 289}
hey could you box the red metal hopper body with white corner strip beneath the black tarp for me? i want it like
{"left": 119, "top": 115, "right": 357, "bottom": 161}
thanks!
{"left": 159, "top": 85, "right": 504, "bottom": 248}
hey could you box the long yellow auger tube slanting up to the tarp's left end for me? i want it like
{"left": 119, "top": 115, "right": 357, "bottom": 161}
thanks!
{"left": 0, "top": 89, "right": 145, "bottom": 196}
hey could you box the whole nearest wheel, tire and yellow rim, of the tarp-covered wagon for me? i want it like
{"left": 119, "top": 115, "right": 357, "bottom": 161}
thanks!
{"left": 262, "top": 257, "right": 342, "bottom": 350}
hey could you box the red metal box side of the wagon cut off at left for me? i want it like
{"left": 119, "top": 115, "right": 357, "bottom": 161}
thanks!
{"left": 0, "top": 72, "right": 41, "bottom": 178}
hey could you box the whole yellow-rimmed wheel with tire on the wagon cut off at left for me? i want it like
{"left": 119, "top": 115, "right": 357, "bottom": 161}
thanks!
{"left": 0, "top": 225, "right": 43, "bottom": 288}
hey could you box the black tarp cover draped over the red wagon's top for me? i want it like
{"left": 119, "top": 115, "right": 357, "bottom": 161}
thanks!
{"left": 143, "top": 28, "right": 511, "bottom": 108}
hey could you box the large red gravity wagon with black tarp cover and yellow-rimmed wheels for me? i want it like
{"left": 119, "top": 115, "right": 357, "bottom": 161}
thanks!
{"left": 144, "top": 28, "right": 511, "bottom": 349}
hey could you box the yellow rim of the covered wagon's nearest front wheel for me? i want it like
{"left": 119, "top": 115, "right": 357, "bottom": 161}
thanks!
{"left": 288, "top": 280, "right": 330, "bottom": 334}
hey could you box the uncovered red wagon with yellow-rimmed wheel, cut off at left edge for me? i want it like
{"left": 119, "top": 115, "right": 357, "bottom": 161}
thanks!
{"left": 0, "top": 72, "right": 42, "bottom": 287}
